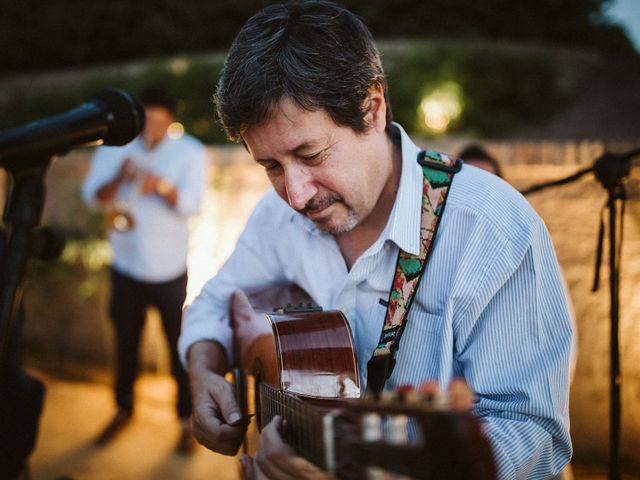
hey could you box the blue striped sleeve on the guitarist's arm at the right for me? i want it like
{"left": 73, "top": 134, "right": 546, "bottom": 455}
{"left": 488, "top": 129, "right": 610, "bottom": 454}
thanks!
{"left": 455, "top": 221, "right": 574, "bottom": 480}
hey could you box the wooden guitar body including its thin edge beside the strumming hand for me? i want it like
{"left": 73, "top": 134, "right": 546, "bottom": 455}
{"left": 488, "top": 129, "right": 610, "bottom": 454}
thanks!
{"left": 231, "top": 285, "right": 360, "bottom": 462}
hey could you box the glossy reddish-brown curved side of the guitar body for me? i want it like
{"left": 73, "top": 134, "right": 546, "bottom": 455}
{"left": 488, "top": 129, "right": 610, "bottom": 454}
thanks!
{"left": 232, "top": 284, "right": 360, "bottom": 399}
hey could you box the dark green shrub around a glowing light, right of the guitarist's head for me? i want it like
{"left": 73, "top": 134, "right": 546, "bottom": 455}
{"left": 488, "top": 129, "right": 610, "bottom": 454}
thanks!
{"left": 383, "top": 45, "right": 568, "bottom": 137}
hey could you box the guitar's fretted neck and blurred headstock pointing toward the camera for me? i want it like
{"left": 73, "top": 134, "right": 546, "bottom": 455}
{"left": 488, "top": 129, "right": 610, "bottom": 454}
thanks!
{"left": 259, "top": 384, "right": 496, "bottom": 480}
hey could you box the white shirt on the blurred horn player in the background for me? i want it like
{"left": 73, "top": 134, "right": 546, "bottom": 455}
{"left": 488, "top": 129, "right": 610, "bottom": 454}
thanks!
{"left": 82, "top": 135, "right": 207, "bottom": 282}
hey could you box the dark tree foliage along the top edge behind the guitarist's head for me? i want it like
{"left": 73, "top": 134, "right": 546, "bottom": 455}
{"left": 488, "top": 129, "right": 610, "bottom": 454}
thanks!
{"left": 0, "top": 0, "right": 632, "bottom": 73}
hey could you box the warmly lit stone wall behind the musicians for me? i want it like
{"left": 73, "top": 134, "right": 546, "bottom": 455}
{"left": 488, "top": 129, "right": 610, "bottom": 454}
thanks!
{"left": 13, "top": 140, "right": 640, "bottom": 468}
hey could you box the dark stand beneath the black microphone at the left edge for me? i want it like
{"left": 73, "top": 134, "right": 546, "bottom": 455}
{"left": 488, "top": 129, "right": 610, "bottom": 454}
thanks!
{"left": 0, "top": 154, "right": 57, "bottom": 478}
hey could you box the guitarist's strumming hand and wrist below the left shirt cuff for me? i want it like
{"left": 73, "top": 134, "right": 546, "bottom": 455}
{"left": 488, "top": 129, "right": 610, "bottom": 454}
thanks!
{"left": 189, "top": 342, "right": 247, "bottom": 455}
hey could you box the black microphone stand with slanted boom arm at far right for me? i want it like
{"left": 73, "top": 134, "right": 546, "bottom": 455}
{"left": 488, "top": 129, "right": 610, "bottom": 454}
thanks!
{"left": 521, "top": 148, "right": 640, "bottom": 480}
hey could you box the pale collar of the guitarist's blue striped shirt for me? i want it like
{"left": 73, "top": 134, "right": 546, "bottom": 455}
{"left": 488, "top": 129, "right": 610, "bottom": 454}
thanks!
{"left": 291, "top": 123, "right": 422, "bottom": 255}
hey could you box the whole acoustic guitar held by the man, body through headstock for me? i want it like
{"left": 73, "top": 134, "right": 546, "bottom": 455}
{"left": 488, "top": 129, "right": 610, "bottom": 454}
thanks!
{"left": 232, "top": 289, "right": 495, "bottom": 480}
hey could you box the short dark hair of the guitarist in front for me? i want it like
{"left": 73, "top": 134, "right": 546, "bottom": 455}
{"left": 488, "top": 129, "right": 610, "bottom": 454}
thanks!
{"left": 214, "top": 1, "right": 391, "bottom": 141}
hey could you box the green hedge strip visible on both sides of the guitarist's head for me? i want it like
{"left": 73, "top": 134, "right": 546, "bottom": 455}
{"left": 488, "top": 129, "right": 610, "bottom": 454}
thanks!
{"left": 0, "top": 42, "right": 567, "bottom": 143}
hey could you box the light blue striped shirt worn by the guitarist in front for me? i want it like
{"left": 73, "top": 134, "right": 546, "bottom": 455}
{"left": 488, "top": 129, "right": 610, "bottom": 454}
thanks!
{"left": 179, "top": 124, "right": 573, "bottom": 479}
